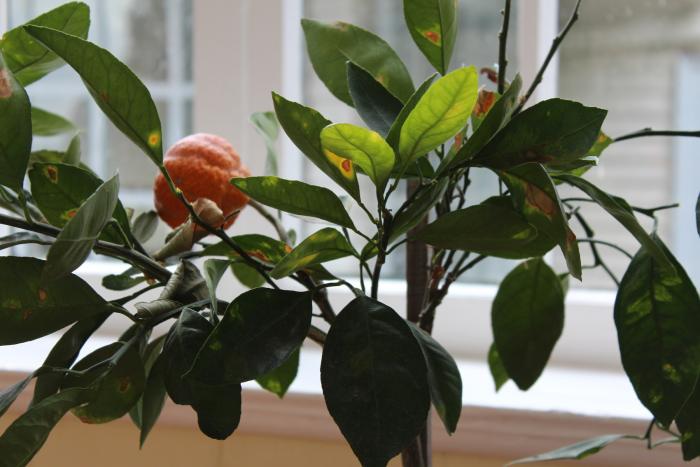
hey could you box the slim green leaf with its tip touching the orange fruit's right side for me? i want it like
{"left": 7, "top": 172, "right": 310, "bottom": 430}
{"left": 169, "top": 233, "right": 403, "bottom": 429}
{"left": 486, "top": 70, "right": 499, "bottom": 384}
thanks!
{"left": 231, "top": 177, "right": 355, "bottom": 229}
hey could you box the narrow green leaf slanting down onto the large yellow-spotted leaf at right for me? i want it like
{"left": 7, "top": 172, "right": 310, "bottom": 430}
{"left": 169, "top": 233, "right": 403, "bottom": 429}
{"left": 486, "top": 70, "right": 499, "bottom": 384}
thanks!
{"left": 556, "top": 174, "right": 672, "bottom": 268}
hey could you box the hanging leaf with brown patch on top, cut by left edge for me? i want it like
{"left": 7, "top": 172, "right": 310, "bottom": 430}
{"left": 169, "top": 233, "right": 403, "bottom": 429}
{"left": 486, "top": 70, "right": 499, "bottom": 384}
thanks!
{"left": 0, "top": 53, "right": 32, "bottom": 192}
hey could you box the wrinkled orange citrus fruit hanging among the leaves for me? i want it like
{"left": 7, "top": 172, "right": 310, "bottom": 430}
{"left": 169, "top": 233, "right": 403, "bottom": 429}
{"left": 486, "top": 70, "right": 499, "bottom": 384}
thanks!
{"left": 153, "top": 133, "right": 250, "bottom": 229}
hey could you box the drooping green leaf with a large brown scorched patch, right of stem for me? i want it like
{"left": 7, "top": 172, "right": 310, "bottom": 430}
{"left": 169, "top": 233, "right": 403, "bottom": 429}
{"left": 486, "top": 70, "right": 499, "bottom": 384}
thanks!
{"left": 498, "top": 164, "right": 581, "bottom": 280}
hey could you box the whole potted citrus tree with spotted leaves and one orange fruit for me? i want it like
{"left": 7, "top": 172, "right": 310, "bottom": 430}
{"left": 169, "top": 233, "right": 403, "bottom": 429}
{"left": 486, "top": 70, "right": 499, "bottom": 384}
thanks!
{"left": 0, "top": 0, "right": 700, "bottom": 467}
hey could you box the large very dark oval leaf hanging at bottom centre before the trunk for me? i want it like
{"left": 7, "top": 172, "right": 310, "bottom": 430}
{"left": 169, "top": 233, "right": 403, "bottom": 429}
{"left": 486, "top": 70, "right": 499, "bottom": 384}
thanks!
{"left": 321, "top": 297, "right": 430, "bottom": 467}
